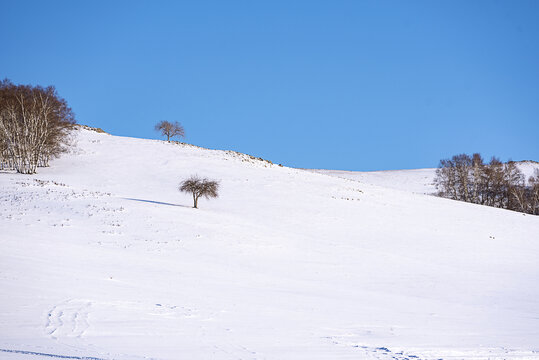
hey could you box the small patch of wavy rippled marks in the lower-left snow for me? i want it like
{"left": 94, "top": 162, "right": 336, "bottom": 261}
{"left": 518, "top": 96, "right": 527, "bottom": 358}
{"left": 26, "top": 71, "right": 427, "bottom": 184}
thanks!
{"left": 45, "top": 299, "right": 92, "bottom": 339}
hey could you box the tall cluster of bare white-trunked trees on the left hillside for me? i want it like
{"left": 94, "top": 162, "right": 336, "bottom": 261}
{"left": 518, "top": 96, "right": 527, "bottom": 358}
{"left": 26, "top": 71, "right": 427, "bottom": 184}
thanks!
{"left": 0, "top": 79, "right": 75, "bottom": 174}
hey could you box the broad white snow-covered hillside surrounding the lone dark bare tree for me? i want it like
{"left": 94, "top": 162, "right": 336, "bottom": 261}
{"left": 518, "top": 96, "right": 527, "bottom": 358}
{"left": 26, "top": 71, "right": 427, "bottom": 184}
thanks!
{"left": 0, "top": 130, "right": 539, "bottom": 360}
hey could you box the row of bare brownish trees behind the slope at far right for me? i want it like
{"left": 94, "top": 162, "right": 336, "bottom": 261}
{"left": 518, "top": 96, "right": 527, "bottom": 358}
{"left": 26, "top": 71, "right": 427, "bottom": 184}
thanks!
{"left": 435, "top": 154, "right": 539, "bottom": 215}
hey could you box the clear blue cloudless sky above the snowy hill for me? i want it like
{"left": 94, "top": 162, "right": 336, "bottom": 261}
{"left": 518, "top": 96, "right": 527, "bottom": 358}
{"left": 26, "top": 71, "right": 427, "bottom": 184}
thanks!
{"left": 0, "top": 0, "right": 539, "bottom": 170}
